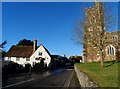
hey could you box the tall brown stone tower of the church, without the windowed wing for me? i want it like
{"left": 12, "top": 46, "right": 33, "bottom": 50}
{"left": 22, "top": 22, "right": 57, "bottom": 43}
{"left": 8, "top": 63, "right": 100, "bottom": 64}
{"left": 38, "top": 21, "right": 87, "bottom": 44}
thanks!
{"left": 83, "top": 2, "right": 104, "bottom": 62}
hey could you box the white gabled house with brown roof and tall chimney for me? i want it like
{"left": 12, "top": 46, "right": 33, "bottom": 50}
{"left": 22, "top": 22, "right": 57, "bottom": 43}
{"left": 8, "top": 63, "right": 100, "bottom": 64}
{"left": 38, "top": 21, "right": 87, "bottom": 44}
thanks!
{"left": 5, "top": 38, "right": 51, "bottom": 67}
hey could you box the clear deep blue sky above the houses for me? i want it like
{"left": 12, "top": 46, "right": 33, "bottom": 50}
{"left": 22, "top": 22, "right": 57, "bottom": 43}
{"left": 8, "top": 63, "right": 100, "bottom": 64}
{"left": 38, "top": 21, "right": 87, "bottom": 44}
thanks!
{"left": 2, "top": 2, "right": 118, "bottom": 57}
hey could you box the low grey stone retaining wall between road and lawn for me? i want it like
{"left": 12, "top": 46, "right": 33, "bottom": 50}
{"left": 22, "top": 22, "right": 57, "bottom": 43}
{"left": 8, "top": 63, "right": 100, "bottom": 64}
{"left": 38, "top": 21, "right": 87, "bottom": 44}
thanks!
{"left": 74, "top": 66, "right": 99, "bottom": 88}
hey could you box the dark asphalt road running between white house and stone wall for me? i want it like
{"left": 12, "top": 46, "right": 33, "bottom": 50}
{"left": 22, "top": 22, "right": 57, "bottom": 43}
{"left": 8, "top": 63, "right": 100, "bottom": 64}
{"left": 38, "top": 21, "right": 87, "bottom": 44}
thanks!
{"left": 3, "top": 68, "right": 80, "bottom": 89}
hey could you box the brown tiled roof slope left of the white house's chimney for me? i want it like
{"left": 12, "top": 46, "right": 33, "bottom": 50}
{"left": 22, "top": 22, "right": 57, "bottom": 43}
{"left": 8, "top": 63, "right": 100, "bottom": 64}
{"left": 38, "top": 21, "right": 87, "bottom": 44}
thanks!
{"left": 5, "top": 45, "right": 33, "bottom": 58}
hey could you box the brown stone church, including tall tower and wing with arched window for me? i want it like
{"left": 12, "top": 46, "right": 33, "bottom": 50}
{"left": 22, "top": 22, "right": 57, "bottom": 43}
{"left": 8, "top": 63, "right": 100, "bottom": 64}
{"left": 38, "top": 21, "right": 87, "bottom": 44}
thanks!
{"left": 83, "top": 2, "right": 118, "bottom": 62}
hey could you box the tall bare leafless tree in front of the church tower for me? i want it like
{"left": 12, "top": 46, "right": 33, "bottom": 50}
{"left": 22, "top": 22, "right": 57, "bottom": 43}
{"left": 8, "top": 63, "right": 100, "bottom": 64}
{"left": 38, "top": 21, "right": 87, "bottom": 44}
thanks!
{"left": 73, "top": 2, "right": 117, "bottom": 67}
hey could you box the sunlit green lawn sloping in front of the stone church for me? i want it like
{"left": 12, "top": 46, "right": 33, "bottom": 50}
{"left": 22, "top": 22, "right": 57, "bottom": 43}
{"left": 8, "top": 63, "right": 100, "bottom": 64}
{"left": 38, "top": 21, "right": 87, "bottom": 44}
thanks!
{"left": 75, "top": 62, "right": 120, "bottom": 87}
